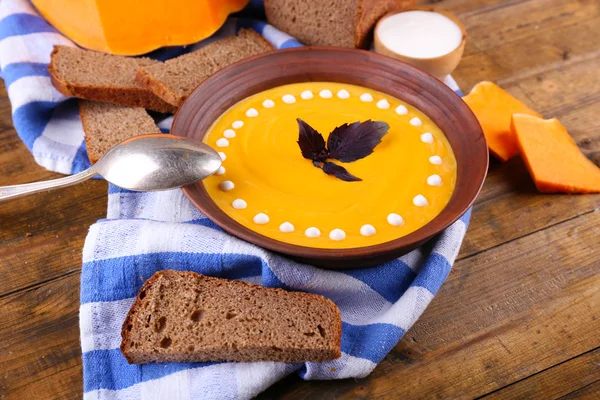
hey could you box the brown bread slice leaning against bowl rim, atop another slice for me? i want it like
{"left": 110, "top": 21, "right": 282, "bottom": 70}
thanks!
{"left": 135, "top": 29, "right": 275, "bottom": 107}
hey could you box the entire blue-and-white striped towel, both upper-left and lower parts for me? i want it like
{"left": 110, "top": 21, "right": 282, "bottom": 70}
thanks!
{"left": 0, "top": 0, "right": 470, "bottom": 399}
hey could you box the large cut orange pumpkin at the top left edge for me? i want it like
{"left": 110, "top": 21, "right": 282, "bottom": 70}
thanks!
{"left": 33, "top": 0, "right": 248, "bottom": 55}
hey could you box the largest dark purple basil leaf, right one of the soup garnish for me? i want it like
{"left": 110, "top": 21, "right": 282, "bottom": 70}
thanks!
{"left": 327, "top": 120, "right": 390, "bottom": 162}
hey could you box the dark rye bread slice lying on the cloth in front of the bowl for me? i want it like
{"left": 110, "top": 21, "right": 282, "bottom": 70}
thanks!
{"left": 121, "top": 270, "right": 342, "bottom": 364}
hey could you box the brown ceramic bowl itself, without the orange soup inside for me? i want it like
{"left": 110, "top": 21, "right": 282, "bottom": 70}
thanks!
{"left": 171, "top": 47, "right": 488, "bottom": 269}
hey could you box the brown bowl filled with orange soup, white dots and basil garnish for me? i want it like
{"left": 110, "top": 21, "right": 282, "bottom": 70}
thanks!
{"left": 171, "top": 47, "right": 488, "bottom": 268}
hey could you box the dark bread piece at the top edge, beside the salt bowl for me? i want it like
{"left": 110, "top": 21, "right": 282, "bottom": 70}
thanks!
{"left": 265, "top": 0, "right": 415, "bottom": 48}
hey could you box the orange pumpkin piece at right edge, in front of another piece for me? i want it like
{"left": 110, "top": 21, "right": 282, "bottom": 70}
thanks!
{"left": 511, "top": 114, "right": 600, "bottom": 193}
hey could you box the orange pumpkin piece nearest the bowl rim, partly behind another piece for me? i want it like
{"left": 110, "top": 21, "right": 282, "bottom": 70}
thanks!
{"left": 463, "top": 81, "right": 541, "bottom": 161}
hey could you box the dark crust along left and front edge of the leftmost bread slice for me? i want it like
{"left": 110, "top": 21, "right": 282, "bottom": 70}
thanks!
{"left": 48, "top": 46, "right": 177, "bottom": 113}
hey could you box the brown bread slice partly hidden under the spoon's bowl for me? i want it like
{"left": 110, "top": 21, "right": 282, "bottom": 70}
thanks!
{"left": 79, "top": 100, "right": 160, "bottom": 164}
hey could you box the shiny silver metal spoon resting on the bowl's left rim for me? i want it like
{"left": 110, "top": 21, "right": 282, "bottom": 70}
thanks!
{"left": 0, "top": 134, "right": 222, "bottom": 201}
